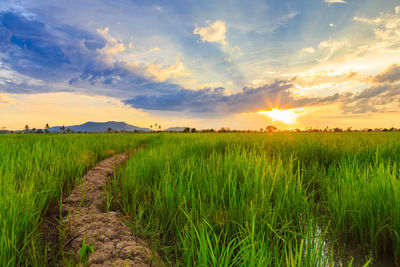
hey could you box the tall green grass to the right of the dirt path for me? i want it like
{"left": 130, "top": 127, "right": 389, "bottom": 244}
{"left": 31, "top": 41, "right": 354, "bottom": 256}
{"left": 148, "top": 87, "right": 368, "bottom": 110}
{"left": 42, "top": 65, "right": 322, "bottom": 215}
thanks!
{"left": 119, "top": 133, "right": 400, "bottom": 266}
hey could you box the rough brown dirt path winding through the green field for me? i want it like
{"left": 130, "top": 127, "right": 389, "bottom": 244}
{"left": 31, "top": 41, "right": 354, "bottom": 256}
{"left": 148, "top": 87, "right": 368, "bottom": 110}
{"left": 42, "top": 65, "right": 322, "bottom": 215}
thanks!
{"left": 62, "top": 150, "right": 155, "bottom": 267}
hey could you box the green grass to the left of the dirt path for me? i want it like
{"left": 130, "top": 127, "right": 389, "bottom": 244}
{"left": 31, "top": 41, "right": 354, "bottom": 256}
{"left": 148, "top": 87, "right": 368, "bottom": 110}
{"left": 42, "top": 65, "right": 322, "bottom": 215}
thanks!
{"left": 0, "top": 134, "right": 150, "bottom": 266}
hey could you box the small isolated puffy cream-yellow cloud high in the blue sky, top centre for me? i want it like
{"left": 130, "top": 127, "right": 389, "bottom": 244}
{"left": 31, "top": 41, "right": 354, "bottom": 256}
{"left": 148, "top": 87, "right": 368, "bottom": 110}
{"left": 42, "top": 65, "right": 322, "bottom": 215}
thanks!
{"left": 193, "top": 20, "right": 228, "bottom": 45}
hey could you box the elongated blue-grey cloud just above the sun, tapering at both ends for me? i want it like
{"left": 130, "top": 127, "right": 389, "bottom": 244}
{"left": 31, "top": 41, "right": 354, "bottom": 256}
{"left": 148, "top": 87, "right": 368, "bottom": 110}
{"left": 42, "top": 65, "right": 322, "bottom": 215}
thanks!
{"left": 125, "top": 80, "right": 348, "bottom": 114}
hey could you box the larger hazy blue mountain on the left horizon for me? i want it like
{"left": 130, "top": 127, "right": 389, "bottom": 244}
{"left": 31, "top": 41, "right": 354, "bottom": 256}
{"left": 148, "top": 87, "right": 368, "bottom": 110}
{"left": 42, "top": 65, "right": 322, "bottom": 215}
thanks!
{"left": 49, "top": 121, "right": 152, "bottom": 133}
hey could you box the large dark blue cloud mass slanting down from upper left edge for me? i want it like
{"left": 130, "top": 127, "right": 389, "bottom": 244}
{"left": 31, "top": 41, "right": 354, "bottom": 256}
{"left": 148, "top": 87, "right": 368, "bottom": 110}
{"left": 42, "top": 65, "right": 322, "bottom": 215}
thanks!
{"left": 0, "top": 11, "right": 182, "bottom": 97}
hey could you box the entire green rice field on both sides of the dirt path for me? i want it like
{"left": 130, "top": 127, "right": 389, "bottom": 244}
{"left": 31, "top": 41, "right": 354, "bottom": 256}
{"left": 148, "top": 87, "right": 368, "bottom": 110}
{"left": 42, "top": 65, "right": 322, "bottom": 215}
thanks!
{"left": 0, "top": 132, "right": 400, "bottom": 266}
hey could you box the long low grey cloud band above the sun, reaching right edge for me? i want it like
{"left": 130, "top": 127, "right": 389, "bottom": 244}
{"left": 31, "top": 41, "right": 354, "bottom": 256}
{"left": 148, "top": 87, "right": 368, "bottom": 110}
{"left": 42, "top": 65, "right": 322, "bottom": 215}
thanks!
{"left": 125, "top": 73, "right": 400, "bottom": 115}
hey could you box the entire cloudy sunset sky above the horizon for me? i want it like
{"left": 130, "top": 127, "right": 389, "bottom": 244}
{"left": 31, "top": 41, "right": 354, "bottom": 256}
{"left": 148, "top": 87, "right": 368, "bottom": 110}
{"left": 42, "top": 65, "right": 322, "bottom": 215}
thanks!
{"left": 0, "top": 0, "right": 400, "bottom": 129}
